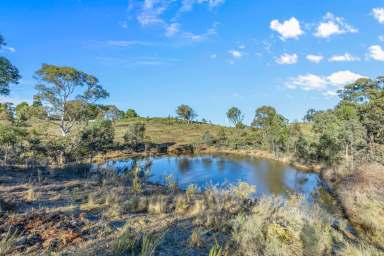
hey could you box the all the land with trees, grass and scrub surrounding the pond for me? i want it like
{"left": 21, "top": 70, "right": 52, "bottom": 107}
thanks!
{"left": 0, "top": 34, "right": 384, "bottom": 256}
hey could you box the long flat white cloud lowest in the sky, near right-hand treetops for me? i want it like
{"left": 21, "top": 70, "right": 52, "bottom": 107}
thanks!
{"left": 287, "top": 70, "right": 363, "bottom": 92}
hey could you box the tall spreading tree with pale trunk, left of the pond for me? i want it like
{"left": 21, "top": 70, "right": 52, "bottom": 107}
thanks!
{"left": 35, "top": 64, "right": 109, "bottom": 137}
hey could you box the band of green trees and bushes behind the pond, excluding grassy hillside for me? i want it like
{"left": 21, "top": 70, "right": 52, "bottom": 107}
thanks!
{"left": 0, "top": 33, "right": 384, "bottom": 168}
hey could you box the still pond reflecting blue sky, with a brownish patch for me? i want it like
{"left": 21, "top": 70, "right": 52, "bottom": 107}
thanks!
{"left": 100, "top": 155, "right": 333, "bottom": 208}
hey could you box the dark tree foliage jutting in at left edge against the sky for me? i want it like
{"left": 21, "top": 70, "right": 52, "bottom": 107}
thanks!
{"left": 0, "top": 35, "right": 21, "bottom": 95}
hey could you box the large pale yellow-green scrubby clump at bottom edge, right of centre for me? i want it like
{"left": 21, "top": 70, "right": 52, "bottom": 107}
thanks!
{"left": 232, "top": 197, "right": 332, "bottom": 255}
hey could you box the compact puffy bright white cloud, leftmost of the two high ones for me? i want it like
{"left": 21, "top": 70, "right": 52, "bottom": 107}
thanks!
{"left": 270, "top": 17, "right": 304, "bottom": 40}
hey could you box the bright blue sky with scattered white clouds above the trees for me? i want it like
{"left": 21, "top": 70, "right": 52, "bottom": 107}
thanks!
{"left": 0, "top": 0, "right": 384, "bottom": 124}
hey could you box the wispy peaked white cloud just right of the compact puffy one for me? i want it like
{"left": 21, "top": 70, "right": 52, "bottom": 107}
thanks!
{"left": 314, "top": 12, "right": 358, "bottom": 38}
